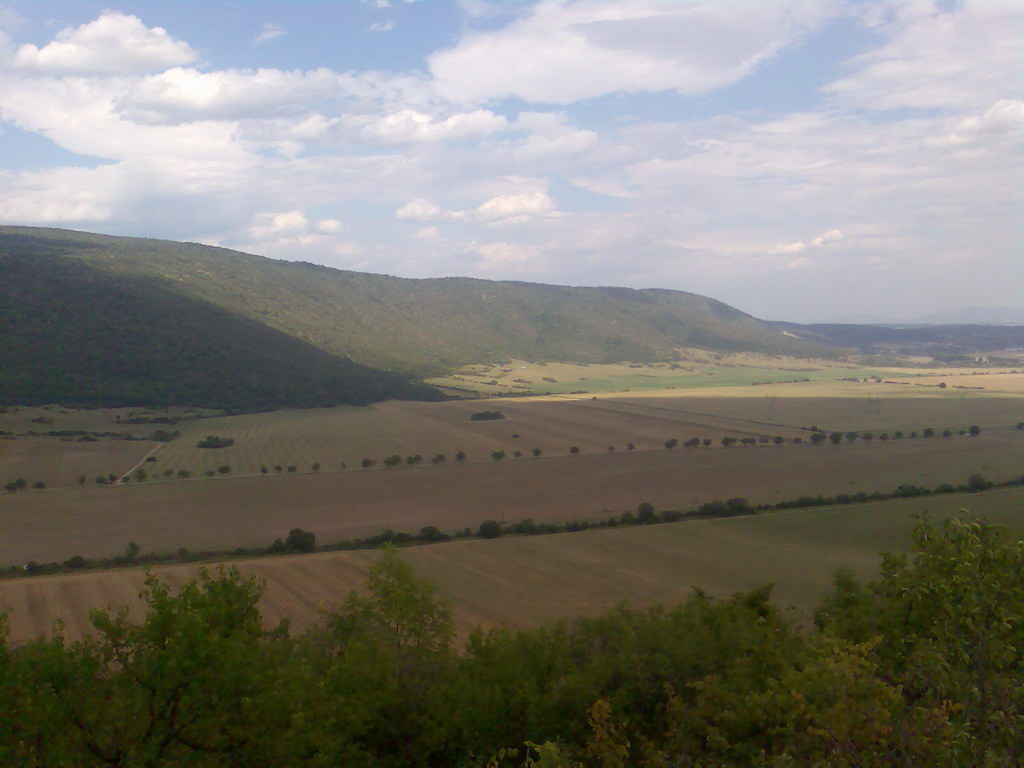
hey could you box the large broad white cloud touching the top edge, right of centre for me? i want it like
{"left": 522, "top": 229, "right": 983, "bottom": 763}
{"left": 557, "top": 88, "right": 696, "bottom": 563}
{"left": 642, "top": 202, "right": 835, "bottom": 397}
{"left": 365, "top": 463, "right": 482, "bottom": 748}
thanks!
{"left": 428, "top": 0, "right": 835, "bottom": 103}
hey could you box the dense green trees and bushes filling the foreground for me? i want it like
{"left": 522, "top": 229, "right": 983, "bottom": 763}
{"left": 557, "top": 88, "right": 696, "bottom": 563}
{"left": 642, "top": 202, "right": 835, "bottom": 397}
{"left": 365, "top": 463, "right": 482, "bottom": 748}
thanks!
{"left": 0, "top": 520, "right": 1024, "bottom": 768}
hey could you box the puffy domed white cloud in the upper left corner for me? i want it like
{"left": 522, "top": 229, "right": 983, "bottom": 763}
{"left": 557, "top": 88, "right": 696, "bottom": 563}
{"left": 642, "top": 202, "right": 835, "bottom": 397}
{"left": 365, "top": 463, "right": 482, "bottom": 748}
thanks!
{"left": 13, "top": 10, "right": 199, "bottom": 75}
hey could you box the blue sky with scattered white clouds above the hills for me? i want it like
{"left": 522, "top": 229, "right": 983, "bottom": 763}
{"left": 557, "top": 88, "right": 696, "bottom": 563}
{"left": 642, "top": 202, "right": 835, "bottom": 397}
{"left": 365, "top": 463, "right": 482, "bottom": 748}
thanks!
{"left": 0, "top": 0, "right": 1024, "bottom": 322}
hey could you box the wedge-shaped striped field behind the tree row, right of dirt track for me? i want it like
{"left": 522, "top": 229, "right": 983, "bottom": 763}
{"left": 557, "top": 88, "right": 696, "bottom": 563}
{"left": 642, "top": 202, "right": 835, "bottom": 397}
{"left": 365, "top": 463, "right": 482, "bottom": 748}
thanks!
{"left": 134, "top": 398, "right": 815, "bottom": 477}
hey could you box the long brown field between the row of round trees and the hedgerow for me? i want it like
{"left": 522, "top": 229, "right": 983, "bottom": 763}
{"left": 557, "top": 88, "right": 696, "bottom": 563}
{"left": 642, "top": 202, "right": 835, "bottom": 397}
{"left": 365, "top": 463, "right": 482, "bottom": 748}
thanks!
{"left": 0, "top": 430, "right": 1024, "bottom": 564}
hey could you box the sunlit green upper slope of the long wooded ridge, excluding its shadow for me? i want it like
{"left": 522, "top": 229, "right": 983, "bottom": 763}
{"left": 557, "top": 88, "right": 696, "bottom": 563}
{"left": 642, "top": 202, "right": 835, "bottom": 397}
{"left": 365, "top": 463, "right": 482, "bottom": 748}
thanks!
{"left": 0, "top": 226, "right": 828, "bottom": 375}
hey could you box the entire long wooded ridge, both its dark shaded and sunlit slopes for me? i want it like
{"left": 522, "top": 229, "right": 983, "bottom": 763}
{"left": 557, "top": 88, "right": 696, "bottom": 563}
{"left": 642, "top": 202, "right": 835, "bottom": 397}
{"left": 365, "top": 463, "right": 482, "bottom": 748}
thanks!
{"left": 0, "top": 226, "right": 836, "bottom": 409}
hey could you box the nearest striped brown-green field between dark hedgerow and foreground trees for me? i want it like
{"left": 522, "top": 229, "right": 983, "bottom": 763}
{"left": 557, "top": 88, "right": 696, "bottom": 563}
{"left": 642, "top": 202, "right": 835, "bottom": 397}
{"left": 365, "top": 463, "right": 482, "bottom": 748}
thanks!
{"left": 0, "top": 488, "right": 1024, "bottom": 641}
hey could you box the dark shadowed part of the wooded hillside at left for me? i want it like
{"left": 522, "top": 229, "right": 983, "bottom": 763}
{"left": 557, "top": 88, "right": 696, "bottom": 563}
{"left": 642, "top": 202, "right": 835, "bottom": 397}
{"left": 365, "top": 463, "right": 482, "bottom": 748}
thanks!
{"left": 0, "top": 241, "right": 437, "bottom": 410}
